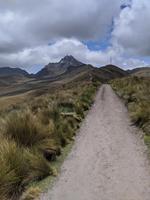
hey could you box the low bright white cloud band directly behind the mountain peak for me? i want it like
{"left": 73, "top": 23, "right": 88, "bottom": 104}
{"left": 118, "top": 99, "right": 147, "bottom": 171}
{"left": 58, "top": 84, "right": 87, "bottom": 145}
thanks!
{"left": 0, "top": 38, "right": 145, "bottom": 72}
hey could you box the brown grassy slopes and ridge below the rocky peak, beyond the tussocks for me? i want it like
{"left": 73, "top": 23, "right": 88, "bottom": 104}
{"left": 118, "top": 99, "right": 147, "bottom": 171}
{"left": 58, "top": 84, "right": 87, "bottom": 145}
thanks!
{"left": 0, "top": 64, "right": 128, "bottom": 97}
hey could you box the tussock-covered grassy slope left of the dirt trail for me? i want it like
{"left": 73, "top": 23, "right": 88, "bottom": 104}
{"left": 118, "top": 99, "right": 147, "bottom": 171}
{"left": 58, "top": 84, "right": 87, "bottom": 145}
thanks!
{"left": 0, "top": 77, "right": 100, "bottom": 200}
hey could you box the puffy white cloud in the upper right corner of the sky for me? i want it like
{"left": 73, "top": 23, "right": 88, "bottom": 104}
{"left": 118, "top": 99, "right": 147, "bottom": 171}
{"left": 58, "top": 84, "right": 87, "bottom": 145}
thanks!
{"left": 112, "top": 0, "right": 150, "bottom": 56}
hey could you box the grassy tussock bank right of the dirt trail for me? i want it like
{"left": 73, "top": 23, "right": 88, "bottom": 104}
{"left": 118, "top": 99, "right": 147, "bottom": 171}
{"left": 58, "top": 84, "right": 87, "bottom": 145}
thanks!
{"left": 111, "top": 77, "right": 150, "bottom": 145}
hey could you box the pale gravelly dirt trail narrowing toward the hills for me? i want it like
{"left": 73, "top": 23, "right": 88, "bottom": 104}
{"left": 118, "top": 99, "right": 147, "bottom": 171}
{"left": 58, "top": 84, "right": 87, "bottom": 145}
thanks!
{"left": 41, "top": 85, "right": 150, "bottom": 200}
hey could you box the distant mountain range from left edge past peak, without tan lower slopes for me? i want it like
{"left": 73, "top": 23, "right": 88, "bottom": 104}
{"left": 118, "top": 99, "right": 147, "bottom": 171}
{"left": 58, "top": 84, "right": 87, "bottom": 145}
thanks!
{"left": 0, "top": 55, "right": 128, "bottom": 83}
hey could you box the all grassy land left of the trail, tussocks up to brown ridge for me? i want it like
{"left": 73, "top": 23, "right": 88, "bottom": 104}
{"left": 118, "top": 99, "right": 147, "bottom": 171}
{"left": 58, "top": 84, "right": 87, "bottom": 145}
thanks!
{"left": 0, "top": 61, "right": 129, "bottom": 200}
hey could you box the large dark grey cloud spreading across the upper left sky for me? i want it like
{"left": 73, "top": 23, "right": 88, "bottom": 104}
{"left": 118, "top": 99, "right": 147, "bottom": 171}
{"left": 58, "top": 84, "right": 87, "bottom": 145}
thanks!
{"left": 0, "top": 0, "right": 120, "bottom": 52}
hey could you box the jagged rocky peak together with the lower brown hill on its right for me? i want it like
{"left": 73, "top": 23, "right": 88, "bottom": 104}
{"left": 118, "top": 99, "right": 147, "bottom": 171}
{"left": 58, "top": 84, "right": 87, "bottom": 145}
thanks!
{"left": 35, "top": 56, "right": 128, "bottom": 82}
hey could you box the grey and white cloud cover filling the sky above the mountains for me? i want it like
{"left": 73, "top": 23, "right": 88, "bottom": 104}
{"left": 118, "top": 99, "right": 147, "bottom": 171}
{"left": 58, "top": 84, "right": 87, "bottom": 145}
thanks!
{"left": 0, "top": 0, "right": 150, "bottom": 71}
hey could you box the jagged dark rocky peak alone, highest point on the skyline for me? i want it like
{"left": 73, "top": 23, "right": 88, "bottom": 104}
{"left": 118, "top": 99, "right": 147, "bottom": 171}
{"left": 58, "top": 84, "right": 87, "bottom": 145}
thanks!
{"left": 36, "top": 56, "right": 84, "bottom": 78}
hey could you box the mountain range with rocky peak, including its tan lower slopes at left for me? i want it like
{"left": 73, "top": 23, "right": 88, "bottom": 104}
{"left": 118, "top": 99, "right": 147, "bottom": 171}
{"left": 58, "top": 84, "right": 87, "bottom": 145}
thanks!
{"left": 0, "top": 56, "right": 129, "bottom": 96}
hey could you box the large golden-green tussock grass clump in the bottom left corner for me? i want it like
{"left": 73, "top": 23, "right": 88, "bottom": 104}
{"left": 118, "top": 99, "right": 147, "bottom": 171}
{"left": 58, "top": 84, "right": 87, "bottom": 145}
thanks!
{"left": 0, "top": 139, "right": 53, "bottom": 199}
